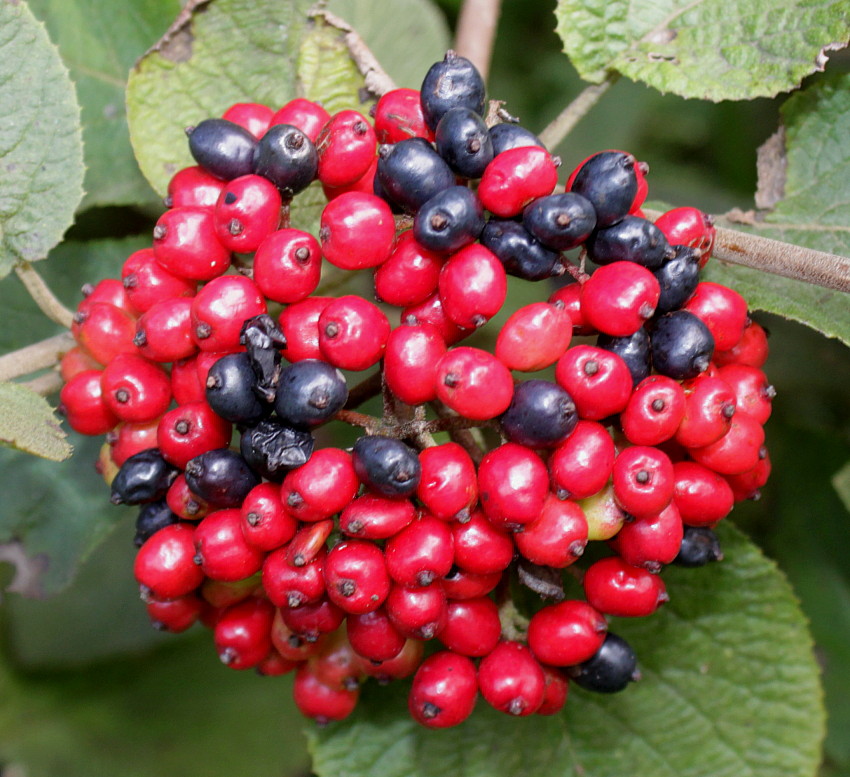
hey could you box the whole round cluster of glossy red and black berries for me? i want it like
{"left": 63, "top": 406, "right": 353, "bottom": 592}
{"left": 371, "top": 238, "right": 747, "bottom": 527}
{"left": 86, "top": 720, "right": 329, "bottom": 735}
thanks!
{"left": 61, "top": 52, "right": 773, "bottom": 727}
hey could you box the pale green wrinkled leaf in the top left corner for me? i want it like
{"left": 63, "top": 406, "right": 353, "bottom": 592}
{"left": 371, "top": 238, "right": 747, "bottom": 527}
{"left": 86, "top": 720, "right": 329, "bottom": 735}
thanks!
{"left": 0, "top": 2, "right": 83, "bottom": 278}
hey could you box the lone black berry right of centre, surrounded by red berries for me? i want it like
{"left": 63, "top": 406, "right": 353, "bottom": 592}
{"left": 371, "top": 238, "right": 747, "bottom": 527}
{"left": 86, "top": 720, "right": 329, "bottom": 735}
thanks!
{"left": 499, "top": 380, "right": 578, "bottom": 448}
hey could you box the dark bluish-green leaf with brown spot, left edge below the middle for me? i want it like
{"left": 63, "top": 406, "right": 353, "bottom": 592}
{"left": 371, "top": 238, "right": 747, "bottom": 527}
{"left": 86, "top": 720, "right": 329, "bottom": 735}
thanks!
{"left": 0, "top": 435, "right": 129, "bottom": 597}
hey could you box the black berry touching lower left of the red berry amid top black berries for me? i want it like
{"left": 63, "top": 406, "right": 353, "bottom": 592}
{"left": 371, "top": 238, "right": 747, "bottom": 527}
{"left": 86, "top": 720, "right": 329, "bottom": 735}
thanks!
{"left": 413, "top": 186, "right": 484, "bottom": 254}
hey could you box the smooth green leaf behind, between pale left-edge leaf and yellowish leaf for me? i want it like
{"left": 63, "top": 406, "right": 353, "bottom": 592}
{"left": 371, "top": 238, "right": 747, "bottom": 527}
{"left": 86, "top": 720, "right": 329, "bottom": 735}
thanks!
{"left": 29, "top": 0, "right": 180, "bottom": 208}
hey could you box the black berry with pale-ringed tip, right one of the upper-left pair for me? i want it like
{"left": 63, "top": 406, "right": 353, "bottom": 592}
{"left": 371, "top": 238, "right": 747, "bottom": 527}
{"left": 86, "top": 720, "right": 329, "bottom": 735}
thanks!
{"left": 251, "top": 124, "right": 319, "bottom": 194}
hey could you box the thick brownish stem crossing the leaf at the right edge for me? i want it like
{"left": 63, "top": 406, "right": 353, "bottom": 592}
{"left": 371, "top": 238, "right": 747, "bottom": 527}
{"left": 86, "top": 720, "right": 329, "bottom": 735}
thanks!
{"left": 644, "top": 210, "right": 850, "bottom": 292}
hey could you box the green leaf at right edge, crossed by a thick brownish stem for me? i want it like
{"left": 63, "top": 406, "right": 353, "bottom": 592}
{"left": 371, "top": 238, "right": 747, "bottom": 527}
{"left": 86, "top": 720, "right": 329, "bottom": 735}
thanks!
{"left": 706, "top": 73, "right": 850, "bottom": 345}
